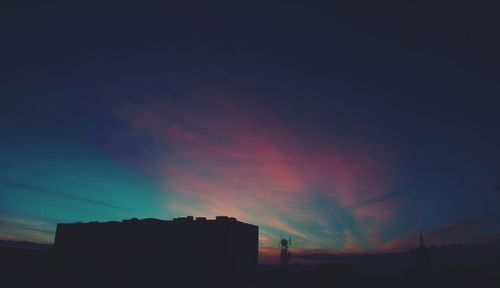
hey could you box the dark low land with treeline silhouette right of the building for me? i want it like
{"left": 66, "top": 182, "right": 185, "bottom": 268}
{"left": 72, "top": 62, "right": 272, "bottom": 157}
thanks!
{"left": 258, "top": 241, "right": 500, "bottom": 288}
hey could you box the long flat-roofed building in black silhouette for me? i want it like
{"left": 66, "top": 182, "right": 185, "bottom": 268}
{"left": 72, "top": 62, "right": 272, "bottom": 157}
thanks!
{"left": 55, "top": 216, "right": 258, "bottom": 287}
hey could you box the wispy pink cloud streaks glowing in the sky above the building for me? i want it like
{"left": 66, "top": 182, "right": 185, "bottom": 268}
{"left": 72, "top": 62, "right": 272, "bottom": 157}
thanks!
{"left": 110, "top": 91, "right": 398, "bottom": 253}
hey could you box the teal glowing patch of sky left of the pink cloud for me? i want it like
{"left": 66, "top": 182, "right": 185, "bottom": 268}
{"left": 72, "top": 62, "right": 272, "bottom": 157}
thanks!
{"left": 0, "top": 139, "right": 167, "bottom": 243}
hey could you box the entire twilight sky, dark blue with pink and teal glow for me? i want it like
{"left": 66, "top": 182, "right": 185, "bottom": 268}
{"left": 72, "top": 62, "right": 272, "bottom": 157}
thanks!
{"left": 0, "top": 1, "right": 500, "bottom": 262}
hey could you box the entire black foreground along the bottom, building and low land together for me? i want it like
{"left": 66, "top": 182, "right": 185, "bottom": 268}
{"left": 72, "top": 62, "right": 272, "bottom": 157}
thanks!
{"left": 0, "top": 217, "right": 500, "bottom": 288}
